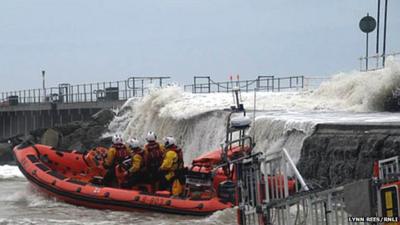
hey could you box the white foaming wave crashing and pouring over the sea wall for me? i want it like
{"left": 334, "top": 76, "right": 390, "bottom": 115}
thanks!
{"left": 107, "top": 58, "right": 400, "bottom": 163}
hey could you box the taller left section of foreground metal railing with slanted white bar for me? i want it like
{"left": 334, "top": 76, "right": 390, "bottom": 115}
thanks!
{"left": 237, "top": 149, "right": 308, "bottom": 225}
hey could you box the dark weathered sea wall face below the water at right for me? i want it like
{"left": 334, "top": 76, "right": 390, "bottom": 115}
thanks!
{"left": 297, "top": 124, "right": 400, "bottom": 187}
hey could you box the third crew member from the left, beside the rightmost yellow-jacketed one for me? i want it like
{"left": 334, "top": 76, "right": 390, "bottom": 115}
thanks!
{"left": 144, "top": 131, "right": 164, "bottom": 191}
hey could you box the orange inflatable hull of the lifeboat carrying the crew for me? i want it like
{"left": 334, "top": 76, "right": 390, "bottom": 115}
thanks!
{"left": 14, "top": 144, "right": 233, "bottom": 216}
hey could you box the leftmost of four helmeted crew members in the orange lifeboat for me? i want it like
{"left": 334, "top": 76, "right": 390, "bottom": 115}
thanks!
{"left": 103, "top": 134, "right": 130, "bottom": 186}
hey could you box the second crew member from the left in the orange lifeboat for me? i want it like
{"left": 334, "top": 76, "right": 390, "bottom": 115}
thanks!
{"left": 122, "top": 138, "right": 146, "bottom": 188}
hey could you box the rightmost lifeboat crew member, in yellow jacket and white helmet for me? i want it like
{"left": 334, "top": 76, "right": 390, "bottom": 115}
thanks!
{"left": 160, "top": 137, "right": 184, "bottom": 195}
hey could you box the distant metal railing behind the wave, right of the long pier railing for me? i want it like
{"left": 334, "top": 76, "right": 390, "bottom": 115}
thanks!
{"left": 184, "top": 76, "right": 304, "bottom": 93}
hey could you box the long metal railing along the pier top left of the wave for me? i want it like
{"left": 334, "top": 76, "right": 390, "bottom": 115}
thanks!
{"left": 0, "top": 77, "right": 169, "bottom": 106}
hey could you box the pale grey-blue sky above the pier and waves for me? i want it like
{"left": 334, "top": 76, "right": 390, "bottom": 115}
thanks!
{"left": 0, "top": 0, "right": 400, "bottom": 91}
